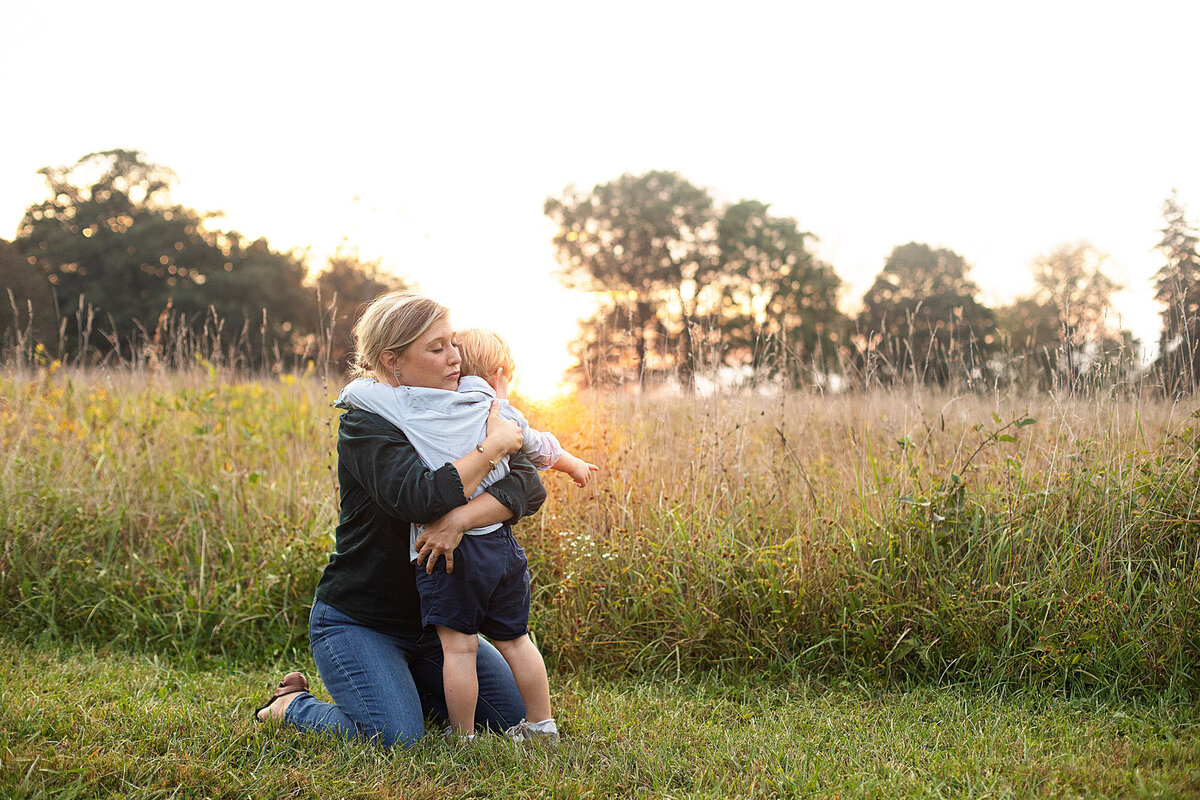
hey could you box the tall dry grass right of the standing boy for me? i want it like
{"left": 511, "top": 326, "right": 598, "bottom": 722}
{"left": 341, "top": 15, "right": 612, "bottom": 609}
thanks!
{"left": 527, "top": 390, "right": 1200, "bottom": 691}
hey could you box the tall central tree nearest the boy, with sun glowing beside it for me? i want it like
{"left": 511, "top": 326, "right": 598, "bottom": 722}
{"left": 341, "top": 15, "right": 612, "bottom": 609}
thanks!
{"left": 545, "top": 172, "right": 714, "bottom": 385}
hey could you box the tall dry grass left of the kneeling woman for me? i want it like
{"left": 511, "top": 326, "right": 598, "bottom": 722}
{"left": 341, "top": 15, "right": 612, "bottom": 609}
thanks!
{"left": 0, "top": 362, "right": 337, "bottom": 654}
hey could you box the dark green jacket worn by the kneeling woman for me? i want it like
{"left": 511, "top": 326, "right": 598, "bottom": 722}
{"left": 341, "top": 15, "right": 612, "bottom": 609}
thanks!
{"left": 317, "top": 410, "right": 546, "bottom": 632}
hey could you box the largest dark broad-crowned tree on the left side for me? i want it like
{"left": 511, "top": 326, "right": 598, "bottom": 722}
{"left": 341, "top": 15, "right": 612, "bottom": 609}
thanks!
{"left": 16, "top": 150, "right": 311, "bottom": 360}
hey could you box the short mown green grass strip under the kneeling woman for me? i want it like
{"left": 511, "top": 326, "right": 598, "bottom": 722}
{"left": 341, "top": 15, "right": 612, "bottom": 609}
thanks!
{"left": 0, "top": 639, "right": 1200, "bottom": 799}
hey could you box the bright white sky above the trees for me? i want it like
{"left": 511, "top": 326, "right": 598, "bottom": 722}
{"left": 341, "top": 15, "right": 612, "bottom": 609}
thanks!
{"left": 0, "top": 0, "right": 1200, "bottom": 393}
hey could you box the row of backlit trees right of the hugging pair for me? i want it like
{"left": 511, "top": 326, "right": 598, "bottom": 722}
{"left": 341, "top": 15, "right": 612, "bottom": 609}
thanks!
{"left": 545, "top": 172, "right": 1200, "bottom": 393}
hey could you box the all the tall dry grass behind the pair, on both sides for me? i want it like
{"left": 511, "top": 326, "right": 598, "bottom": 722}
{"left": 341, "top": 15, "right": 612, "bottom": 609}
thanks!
{"left": 0, "top": 367, "right": 1200, "bottom": 692}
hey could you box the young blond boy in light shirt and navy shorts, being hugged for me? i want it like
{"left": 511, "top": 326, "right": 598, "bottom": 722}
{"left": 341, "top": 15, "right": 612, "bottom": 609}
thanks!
{"left": 337, "top": 329, "right": 599, "bottom": 741}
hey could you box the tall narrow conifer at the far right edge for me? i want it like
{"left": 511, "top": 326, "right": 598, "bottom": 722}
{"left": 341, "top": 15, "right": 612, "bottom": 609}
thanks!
{"left": 1154, "top": 192, "right": 1200, "bottom": 395}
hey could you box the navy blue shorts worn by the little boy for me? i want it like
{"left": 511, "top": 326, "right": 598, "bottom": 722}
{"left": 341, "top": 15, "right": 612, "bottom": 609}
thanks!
{"left": 416, "top": 525, "right": 529, "bottom": 642}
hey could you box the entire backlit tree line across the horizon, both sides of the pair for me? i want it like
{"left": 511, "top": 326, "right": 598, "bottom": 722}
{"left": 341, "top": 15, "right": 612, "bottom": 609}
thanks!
{"left": 0, "top": 150, "right": 1200, "bottom": 393}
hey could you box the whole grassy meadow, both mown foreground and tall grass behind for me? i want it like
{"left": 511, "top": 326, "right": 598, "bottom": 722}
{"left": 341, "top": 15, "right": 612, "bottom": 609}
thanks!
{"left": 0, "top": 360, "right": 1200, "bottom": 796}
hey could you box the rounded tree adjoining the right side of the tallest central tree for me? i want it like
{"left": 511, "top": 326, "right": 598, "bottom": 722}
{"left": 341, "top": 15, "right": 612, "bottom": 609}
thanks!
{"left": 714, "top": 200, "right": 842, "bottom": 384}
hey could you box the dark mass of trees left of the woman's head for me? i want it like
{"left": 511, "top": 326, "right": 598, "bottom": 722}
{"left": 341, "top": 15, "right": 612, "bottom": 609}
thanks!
{"left": 0, "top": 150, "right": 408, "bottom": 369}
